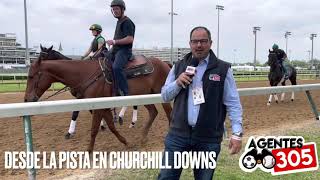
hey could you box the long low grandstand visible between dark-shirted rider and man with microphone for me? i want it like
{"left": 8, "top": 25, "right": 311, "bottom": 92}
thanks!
{"left": 133, "top": 48, "right": 191, "bottom": 63}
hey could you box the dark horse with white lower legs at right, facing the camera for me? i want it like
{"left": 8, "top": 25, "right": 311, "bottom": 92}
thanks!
{"left": 267, "top": 50, "right": 297, "bottom": 105}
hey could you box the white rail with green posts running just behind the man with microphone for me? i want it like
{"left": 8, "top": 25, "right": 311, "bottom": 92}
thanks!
{"left": 0, "top": 84, "right": 320, "bottom": 179}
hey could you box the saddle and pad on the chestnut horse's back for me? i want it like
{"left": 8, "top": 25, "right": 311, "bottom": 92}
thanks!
{"left": 104, "top": 55, "right": 154, "bottom": 82}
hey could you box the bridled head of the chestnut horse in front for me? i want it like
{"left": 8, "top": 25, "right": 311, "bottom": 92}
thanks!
{"left": 24, "top": 59, "right": 52, "bottom": 102}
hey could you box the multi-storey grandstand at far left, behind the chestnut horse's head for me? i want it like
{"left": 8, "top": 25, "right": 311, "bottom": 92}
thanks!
{"left": 0, "top": 33, "right": 39, "bottom": 68}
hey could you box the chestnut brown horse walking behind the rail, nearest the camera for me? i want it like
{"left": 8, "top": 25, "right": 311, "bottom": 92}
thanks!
{"left": 25, "top": 58, "right": 172, "bottom": 152}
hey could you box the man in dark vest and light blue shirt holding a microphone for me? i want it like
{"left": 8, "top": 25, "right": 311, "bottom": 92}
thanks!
{"left": 158, "top": 26, "right": 242, "bottom": 180}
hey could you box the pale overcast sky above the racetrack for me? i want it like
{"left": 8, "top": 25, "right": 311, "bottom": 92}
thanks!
{"left": 0, "top": 0, "right": 320, "bottom": 62}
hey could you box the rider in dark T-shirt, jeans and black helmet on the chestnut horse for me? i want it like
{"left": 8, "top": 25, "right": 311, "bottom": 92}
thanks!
{"left": 107, "top": 0, "right": 135, "bottom": 96}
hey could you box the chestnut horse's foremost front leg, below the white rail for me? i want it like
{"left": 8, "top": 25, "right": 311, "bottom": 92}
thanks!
{"left": 88, "top": 110, "right": 102, "bottom": 154}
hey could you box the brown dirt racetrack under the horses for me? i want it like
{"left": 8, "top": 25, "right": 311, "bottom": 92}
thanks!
{"left": 0, "top": 80, "right": 320, "bottom": 179}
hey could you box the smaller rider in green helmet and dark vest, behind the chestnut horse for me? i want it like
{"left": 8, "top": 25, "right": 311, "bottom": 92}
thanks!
{"left": 81, "top": 24, "right": 108, "bottom": 59}
